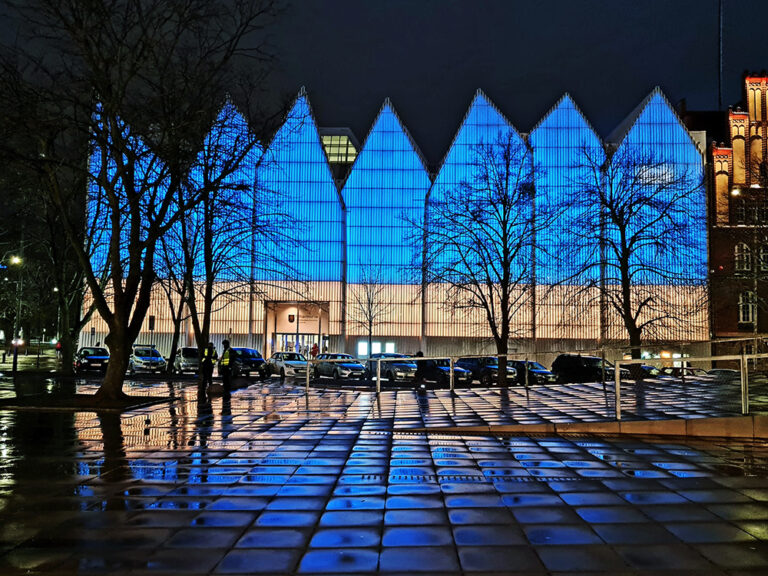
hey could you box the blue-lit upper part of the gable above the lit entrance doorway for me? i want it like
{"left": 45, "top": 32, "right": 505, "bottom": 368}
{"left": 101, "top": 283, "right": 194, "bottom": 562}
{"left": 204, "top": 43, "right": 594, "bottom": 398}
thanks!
{"left": 256, "top": 94, "right": 344, "bottom": 281}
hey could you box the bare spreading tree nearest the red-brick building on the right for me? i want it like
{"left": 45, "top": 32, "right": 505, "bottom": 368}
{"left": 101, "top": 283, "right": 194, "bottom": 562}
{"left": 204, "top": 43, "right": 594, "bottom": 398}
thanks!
{"left": 560, "top": 146, "right": 706, "bottom": 358}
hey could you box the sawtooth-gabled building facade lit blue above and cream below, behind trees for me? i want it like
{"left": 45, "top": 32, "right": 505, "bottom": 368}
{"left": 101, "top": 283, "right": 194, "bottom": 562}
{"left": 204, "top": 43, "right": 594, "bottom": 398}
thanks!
{"left": 83, "top": 89, "right": 708, "bottom": 356}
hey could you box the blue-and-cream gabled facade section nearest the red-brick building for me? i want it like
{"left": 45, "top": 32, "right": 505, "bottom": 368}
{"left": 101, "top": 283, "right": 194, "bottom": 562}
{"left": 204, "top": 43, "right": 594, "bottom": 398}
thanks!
{"left": 607, "top": 89, "right": 708, "bottom": 340}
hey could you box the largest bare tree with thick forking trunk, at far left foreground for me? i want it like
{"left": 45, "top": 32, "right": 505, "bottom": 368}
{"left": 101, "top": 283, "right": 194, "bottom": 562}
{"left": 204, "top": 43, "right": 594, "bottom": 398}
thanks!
{"left": 0, "top": 0, "right": 280, "bottom": 402}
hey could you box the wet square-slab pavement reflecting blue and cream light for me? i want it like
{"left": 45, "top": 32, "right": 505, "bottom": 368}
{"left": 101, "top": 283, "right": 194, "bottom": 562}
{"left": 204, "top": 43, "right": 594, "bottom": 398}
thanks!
{"left": 0, "top": 376, "right": 768, "bottom": 575}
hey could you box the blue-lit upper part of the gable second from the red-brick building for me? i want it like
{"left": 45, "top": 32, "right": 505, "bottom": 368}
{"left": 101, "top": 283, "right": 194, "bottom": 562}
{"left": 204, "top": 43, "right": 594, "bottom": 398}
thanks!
{"left": 528, "top": 94, "right": 605, "bottom": 285}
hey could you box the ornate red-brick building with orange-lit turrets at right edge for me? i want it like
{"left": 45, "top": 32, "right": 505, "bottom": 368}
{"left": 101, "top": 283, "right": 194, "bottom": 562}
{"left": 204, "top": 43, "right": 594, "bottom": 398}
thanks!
{"left": 710, "top": 75, "right": 768, "bottom": 352}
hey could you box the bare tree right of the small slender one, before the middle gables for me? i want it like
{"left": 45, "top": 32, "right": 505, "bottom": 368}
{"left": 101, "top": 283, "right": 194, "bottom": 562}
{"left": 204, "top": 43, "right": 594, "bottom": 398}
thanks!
{"left": 420, "top": 130, "right": 540, "bottom": 385}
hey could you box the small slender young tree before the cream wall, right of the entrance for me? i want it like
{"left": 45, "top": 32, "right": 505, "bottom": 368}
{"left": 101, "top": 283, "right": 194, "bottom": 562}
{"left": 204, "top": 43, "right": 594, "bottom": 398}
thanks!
{"left": 349, "top": 264, "right": 393, "bottom": 355}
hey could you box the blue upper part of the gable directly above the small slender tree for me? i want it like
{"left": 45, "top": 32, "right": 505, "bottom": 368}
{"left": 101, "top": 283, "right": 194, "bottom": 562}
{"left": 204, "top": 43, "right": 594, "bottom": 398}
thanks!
{"left": 343, "top": 102, "right": 431, "bottom": 284}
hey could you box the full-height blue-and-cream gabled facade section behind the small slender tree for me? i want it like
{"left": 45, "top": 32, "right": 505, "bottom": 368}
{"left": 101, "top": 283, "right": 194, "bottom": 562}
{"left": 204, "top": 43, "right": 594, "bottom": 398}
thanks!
{"left": 342, "top": 100, "right": 431, "bottom": 337}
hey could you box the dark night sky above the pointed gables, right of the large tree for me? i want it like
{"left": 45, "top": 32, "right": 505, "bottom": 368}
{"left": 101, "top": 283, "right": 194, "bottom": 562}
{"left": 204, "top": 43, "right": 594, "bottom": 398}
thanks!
{"left": 273, "top": 0, "right": 768, "bottom": 165}
